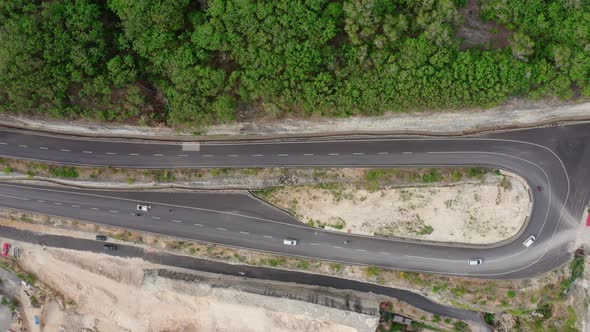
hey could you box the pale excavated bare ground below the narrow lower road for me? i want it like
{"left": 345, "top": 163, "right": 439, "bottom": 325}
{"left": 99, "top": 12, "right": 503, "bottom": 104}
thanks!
{"left": 13, "top": 244, "right": 376, "bottom": 332}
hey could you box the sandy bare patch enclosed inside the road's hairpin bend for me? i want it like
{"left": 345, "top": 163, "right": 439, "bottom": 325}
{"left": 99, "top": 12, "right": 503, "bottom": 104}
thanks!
{"left": 270, "top": 176, "right": 530, "bottom": 244}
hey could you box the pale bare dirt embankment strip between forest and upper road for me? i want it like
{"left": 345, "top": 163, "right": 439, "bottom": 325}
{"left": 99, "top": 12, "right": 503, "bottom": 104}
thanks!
{"left": 0, "top": 99, "right": 590, "bottom": 140}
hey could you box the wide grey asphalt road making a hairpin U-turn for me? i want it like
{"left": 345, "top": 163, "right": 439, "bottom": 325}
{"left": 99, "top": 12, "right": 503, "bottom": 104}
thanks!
{"left": 0, "top": 125, "right": 590, "bottom": 278}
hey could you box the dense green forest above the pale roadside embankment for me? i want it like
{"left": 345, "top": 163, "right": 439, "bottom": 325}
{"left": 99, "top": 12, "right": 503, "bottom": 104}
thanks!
{"left": 0, "top": 0, "right": 590, "bottom": 126}
